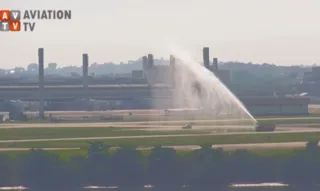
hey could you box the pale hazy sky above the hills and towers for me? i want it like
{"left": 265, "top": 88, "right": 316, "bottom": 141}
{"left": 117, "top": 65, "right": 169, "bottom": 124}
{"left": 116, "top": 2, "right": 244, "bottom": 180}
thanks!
{"left": 0, "top": 0, "right": 320, "bottom": 68}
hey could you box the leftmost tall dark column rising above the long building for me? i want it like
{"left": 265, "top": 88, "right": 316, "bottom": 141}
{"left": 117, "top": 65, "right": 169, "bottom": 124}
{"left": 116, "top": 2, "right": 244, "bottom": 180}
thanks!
{"left": 38, "top": 48, "right": 44, "bottom": 118}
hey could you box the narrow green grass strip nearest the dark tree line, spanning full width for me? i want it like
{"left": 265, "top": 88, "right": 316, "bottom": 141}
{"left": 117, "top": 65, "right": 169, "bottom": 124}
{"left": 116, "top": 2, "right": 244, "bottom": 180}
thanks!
{"left": 0, "top": 132, "right": 320, "bottom": 149}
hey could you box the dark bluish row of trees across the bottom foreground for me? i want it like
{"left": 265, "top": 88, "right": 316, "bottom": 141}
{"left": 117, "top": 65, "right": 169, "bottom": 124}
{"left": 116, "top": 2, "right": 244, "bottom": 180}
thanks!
{"left": 0, "top": 142, "right": 320, "bottom": 190}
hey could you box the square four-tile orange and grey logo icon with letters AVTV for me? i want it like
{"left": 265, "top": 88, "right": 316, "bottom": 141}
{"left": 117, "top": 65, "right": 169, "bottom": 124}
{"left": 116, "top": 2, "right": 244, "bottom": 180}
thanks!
{"left": 0, "top": 10, "right": 21, "bottom": 32}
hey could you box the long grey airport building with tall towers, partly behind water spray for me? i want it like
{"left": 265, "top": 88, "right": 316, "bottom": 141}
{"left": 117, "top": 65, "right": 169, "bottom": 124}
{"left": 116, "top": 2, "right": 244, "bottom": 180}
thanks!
{"left": 0, "top": 47, "right": 309, "bottom": 116}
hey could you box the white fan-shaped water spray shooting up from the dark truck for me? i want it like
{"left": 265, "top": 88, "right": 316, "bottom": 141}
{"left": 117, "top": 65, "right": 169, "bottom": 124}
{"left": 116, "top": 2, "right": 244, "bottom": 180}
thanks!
{"left": 161, "top": 47, "right": 257, "bottom": 125}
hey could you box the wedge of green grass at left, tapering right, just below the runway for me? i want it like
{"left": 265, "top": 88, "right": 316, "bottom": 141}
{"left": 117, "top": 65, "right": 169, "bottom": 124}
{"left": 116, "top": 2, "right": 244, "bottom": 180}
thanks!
{"left": 0, "top": 127, "right": 209, "bottom": 140}
